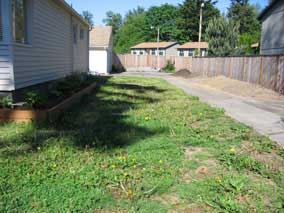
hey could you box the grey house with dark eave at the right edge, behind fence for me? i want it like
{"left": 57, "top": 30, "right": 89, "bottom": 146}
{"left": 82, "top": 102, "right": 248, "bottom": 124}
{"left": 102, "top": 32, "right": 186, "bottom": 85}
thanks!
{"left": 259, "top": 0, "right": 284, "bottom": 55}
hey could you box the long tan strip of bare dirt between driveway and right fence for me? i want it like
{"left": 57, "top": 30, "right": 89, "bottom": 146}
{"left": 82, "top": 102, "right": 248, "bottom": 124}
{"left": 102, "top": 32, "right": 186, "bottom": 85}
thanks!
{"left": 194, "top": 76, "right": 284, "bottom": 101}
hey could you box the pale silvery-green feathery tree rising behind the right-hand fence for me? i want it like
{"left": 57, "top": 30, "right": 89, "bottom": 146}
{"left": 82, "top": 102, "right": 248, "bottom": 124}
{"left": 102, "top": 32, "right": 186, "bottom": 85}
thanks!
{"left": 205, "top": 16, "right": 241, "bottom": 56}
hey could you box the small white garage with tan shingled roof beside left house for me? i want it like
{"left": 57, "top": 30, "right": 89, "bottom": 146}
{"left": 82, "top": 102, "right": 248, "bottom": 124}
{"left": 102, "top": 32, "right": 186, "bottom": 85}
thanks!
{"left": 89, "top": 26, "right": 113, "bottom": 74}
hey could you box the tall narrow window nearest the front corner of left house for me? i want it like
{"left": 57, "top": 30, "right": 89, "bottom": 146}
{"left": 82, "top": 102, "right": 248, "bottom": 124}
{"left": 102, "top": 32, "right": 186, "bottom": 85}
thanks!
{"left": 12, "top": 0, "right": 28, "bottom": 44}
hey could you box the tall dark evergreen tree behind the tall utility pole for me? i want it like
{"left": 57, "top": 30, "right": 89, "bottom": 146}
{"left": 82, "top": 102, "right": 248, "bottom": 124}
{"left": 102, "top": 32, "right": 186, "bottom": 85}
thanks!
{"left": 178, "top": 0, "right": 220, "bottom": 43}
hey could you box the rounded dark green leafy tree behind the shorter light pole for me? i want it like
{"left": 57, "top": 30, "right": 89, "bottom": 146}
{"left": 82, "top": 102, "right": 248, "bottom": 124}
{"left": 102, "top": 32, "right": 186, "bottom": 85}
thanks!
{"left": 145, "top": 4, "right": 179, "bottom": 41}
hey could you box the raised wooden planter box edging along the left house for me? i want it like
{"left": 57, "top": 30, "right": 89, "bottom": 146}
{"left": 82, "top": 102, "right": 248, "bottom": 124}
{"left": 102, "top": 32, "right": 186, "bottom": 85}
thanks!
{"left": 0, "top": 83, "right": 96, "bottom": 122}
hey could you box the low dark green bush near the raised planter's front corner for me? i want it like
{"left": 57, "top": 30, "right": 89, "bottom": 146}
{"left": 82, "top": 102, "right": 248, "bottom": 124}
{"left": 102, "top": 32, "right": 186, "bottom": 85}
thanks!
{"left": 25, "top": 91, "right": 47, "bottom": 109}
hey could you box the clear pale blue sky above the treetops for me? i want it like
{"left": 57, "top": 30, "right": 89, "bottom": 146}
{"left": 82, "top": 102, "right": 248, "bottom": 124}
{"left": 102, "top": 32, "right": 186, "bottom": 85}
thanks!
{"left": 66, "top": 0, "right": 269, "bottom": 25}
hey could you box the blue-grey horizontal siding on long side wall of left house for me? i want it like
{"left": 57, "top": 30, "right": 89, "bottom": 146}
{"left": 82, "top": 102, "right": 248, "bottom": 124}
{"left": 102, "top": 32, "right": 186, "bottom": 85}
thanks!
{"left": 13, "top": 0, "right": 88, "bottom": 89}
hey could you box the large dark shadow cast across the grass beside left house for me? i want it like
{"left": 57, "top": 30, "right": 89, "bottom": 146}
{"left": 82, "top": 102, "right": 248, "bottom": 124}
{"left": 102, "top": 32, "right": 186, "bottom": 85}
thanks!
{"left": 0, "top": 77, "right": 168, "bottom": 156}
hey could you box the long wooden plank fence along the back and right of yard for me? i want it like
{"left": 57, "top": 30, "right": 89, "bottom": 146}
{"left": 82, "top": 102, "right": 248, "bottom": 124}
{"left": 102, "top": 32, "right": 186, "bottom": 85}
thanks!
{"left": 113, "top": 55, "right": 284, "bottom": 94}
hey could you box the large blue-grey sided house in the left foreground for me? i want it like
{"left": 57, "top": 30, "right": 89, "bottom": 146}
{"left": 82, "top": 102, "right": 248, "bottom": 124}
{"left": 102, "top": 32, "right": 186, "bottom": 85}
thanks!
{"left": 0, "top": 0, "right": 89, "bottom": 94}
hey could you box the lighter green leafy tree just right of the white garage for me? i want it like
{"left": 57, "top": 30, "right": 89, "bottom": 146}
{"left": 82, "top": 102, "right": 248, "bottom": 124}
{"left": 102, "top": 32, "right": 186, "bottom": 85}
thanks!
{"left": 114, "top": 13, "right": 147, "bottom": 53}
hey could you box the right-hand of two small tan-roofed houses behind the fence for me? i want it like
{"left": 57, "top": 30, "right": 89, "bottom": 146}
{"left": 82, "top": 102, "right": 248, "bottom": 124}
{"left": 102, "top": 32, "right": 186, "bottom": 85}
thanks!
{"left": 178, "top": 42, "right": 209, "bottom": 57}
